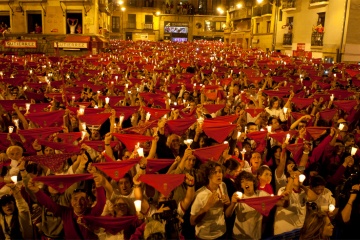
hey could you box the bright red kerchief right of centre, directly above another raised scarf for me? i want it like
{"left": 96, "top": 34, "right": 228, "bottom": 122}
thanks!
{"left": 202, "top": 119, "right": 236, "bottom": 143}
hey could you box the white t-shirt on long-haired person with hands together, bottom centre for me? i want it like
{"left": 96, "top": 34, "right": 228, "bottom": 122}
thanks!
{"left": 190, "top": 182, "right": 228, "bottom": 239}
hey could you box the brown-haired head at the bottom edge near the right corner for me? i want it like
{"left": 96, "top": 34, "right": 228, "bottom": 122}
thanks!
{"left": 300, "top": 211, "right": 334, "bottom": 240}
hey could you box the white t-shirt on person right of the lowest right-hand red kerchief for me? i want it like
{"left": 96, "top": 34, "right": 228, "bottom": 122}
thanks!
{"left": 274, "top": 187, "right": 306, "bottom": 235}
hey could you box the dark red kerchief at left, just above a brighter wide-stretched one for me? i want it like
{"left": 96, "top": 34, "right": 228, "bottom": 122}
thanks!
{"left": 25, "top": 153, "right": 74, "bottom": 172}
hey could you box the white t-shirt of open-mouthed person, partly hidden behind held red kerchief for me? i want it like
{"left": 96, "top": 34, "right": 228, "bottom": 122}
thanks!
{"left": 233, "top": 190, "right": 269, "bottom": 239}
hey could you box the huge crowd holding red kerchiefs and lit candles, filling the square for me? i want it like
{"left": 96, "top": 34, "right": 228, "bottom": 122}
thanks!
{"left": 0, "top": 41, "right": 360, "bottom": 239}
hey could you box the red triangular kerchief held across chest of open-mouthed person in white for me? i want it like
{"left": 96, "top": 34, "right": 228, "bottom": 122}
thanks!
{"left": 238, "top": 196, "right": 282, "bottom": 216}
